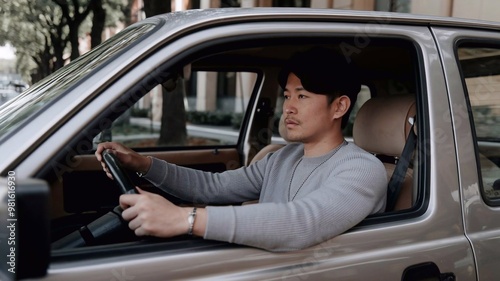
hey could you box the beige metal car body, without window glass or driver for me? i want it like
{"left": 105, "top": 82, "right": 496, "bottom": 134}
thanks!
{"left": 0, "top": 8, "right": 500, "bottom": 281}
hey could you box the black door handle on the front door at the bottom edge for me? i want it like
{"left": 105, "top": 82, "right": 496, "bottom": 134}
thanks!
{"left": 401, "top": 262, "right": 456, "bottom": 281}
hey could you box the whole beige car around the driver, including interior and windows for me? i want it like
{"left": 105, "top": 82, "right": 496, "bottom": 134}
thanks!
{"left": 0, "top": 8, "right": 500, "bottom": 281}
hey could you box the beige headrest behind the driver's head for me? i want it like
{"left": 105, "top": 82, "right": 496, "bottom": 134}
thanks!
{"left": 353, "top": 96, "right": 416, "bottom": 156}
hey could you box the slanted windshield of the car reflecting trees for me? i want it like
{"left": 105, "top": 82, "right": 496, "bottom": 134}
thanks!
{"left": 0, "top": 24, "right": 154, "bottom": 139}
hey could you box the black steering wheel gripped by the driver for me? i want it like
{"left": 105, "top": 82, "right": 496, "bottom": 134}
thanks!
{"left": 51, "top": 151, "right": 136, "bottom": 249}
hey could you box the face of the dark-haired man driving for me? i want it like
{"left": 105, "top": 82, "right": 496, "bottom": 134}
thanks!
{"left": 283, "top": 73, "right": 333, "bottom": 143}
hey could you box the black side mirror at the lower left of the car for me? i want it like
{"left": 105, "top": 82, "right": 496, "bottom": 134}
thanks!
{"left": 0, "top": 175, "right": 50, "bottom": 280}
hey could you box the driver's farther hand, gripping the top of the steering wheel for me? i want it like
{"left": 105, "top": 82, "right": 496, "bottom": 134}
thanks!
{"left": 95, "top": 142, "right": 152, "bottom": 179}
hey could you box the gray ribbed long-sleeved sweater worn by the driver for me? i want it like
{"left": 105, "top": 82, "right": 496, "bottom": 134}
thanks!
{"left": 146, "top": 143, "right": 387, "bottom": 251}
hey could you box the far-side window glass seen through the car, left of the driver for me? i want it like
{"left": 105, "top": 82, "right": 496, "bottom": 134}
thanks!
{"left": 96, "top": 71, "right": 257, "bottom": 148}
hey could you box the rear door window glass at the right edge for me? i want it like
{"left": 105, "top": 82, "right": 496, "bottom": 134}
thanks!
{"left": 458, "top": 46, "right": 500, "bottom": 199}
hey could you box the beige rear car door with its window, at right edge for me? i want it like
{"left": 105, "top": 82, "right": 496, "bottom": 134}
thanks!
{"left": 434, "top": 25, "right": 500, "bottom": 280}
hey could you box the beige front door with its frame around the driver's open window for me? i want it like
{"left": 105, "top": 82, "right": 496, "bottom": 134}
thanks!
{"left": 47, "top": 22, "right": 468, "bottom": 280}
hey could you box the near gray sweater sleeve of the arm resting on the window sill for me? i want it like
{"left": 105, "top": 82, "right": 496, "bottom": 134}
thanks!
{"left": 204, "top": 147, "right": 387, "bottom": 252}
